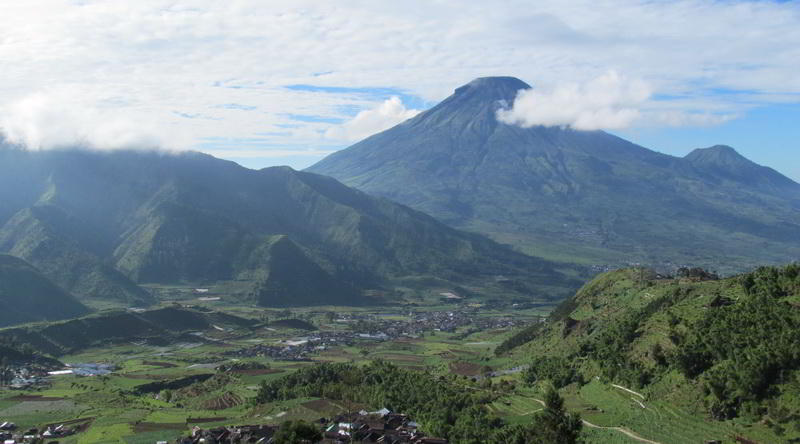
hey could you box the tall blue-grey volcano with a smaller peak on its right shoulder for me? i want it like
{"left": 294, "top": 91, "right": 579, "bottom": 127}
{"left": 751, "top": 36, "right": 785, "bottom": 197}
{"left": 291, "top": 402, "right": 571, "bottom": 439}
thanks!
{"left": 308, "top": 77, "right": 800, "bottom": 273}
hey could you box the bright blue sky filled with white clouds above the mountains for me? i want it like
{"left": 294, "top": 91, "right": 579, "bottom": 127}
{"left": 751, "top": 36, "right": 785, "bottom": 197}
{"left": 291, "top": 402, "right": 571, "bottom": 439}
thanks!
{"left": 0, "top": 0, "right": 800, "bottom": 180}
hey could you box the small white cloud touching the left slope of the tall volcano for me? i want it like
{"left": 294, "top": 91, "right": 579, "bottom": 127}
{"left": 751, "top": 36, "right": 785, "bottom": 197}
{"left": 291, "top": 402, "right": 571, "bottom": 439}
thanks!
{"left": 325, "top": 96, "right": 420, "bottom": 142}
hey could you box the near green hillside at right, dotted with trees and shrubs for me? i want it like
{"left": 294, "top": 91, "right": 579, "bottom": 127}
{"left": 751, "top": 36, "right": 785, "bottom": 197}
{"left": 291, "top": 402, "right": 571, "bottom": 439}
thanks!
{"left": 498, "top": 265, "right": 800, "bottom": 442}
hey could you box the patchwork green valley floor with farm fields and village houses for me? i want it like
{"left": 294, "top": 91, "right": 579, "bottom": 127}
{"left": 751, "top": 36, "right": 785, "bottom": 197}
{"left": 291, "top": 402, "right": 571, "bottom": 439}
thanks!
{"left": 0, "top": 294, "right": 779, "bottom": 444}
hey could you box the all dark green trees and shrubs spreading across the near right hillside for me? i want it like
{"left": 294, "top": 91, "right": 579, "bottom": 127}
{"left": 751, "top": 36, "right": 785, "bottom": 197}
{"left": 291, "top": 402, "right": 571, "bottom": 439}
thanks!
{"left": 525, "top": 264, "right": 800, "bottom": 428}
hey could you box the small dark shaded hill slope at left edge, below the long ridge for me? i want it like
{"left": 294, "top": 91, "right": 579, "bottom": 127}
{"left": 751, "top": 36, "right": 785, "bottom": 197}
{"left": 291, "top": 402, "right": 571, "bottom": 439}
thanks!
{"left": 0, "top": 254, "right": 88, "bottom": 327}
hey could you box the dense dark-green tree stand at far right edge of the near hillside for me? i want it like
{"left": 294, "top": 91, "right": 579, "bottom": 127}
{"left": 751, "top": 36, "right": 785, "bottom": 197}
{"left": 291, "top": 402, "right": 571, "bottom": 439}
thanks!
{"left": 673, "top": 265, "right": 800, "bottom": 419}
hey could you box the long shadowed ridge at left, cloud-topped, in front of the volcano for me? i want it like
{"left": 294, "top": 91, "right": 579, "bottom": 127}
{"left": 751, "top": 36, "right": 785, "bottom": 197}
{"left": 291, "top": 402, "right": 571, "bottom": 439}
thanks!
{"left": 0, "top": 146, "right": 578, "bottom": 306}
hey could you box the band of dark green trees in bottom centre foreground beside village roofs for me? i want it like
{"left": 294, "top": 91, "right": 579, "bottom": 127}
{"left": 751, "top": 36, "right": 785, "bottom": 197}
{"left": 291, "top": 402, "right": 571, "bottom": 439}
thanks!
{"left": 254, "top": 361, "right": 581, "bottom": 443}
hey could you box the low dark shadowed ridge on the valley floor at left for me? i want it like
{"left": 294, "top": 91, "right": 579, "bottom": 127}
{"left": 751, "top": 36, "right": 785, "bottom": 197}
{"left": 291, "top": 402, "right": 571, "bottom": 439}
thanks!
{"left": 0, "top": 307, "right": 254, "bottom": 356}
